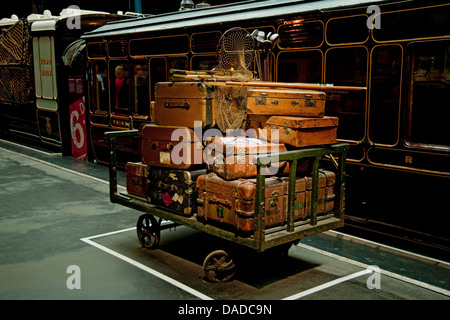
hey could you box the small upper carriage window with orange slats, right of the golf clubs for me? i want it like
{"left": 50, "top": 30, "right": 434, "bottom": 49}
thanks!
{"left": 278, "top": 20, "right": 323, "bottom": 49}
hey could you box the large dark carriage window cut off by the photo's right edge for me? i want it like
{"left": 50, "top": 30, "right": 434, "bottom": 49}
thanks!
{"left": 406, "top": 41, "right": 450, "bottom": 150}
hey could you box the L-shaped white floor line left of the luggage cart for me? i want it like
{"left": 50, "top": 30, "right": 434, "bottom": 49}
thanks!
{"left": 80, "top": 228, "right": 213, "bottom": 300}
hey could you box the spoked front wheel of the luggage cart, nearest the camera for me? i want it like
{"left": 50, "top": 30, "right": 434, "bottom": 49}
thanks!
{"left": 203, "top": 250, "right": 236, "bottom": 283}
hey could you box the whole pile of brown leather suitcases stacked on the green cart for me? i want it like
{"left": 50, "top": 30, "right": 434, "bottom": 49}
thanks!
{"left": 127, "top": 75, "right": 338, "bottom": 234}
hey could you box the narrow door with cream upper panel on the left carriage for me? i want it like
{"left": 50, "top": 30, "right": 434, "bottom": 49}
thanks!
{"left": 32, "top": 31, "right": 61, "bottom": 146}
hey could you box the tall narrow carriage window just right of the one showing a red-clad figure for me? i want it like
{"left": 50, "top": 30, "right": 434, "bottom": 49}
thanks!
{"left": 133, "top": 60, "right": 150, "bottom": 116}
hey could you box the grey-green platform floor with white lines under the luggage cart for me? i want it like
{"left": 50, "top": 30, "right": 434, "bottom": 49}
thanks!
{"left": 0, "top": 140, "right": 450, "bottom": 306}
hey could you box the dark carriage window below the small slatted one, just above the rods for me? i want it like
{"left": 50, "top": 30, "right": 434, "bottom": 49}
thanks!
{"left": 278, "top": 50, "right": 322, "bottom": 83}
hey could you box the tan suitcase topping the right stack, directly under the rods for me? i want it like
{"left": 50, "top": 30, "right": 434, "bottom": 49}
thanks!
{"left": 247, "top": 88, "right": 325, "bottom": 118}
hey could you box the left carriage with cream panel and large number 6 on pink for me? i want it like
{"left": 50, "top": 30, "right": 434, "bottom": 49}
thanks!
{"left": 0, "top": 7, "right": 130, "bottom": 159}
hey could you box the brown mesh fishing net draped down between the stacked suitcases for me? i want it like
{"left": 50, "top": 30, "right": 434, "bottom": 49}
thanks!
{"left": 214, "top": 28, "right": 255, "bottom": 132}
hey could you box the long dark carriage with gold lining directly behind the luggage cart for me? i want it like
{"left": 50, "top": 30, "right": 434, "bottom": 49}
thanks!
{"left": 83, "top": 0, "right": 450, "bottom": 256}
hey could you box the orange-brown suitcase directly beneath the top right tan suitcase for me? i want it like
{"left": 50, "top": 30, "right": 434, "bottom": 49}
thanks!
{"left": 265, "top": 116, "right": 339, "bottom": 147}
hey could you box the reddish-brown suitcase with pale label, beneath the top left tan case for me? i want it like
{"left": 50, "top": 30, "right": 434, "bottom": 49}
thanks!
{"left": 139, "top": 124, "right": 204, "bottom": 169}
